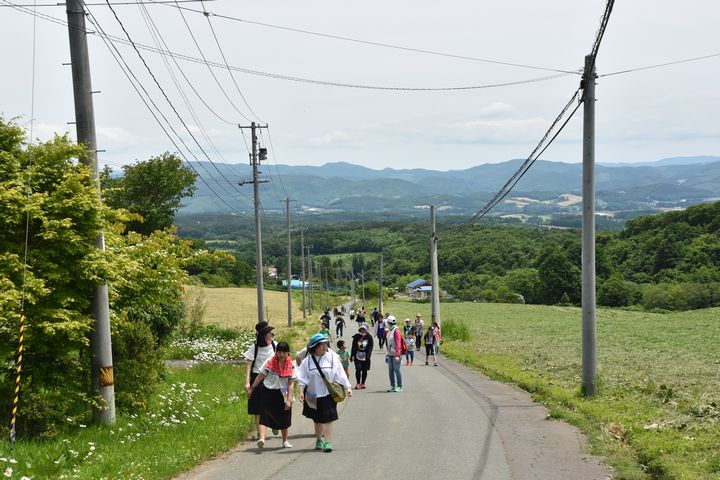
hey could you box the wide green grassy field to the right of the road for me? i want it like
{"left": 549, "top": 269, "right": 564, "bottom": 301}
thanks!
{"left": 385, "top": 302, "right": 720, "bottom": 479}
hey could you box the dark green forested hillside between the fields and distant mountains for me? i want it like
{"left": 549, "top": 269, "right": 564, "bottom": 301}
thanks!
{"left": 181, "top": 203, "right": 720, "bottom": 310}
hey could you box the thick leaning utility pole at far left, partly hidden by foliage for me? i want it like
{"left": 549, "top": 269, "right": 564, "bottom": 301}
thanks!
{"left": 67, "top": 0, "right": 115, "bottom": 425}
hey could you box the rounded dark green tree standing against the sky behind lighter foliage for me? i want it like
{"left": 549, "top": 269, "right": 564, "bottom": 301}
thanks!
{"left": 103, "top": 152, "right": 197, "bottom": 235}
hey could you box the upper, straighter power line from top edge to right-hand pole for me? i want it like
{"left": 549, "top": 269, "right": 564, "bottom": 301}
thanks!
{"left": 152, "top": 0, "right": 581, "bottom": 75}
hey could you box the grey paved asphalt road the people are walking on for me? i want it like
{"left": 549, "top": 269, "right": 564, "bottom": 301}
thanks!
{"left": 178, "top": 322, "right": 611, "bottom": 480}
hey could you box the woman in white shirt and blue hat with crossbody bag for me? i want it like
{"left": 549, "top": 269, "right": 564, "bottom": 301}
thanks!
{"left": 297, "top": 333, "right": 352, "bottom": 452}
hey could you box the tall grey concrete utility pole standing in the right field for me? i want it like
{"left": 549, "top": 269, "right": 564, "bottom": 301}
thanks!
{"left": 582, "top": 55, "right": 597, "bottom": 395}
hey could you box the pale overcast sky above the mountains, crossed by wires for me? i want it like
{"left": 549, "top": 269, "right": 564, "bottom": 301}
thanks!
{"left": 0, "top": 0, "right": 720, "bottom": 170}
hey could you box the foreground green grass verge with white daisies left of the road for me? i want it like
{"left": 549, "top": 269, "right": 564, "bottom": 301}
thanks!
{"left": 0, "top": 365, "right": 254, "bottom": 480}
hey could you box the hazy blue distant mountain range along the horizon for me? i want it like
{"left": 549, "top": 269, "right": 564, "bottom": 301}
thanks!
{"left": 181, "top": 156, "right": 720, "bottom": 216}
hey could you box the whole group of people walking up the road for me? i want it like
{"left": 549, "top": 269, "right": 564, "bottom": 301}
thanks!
{"left": 244, "top": 307, "right": 441, "bottom": 452}
